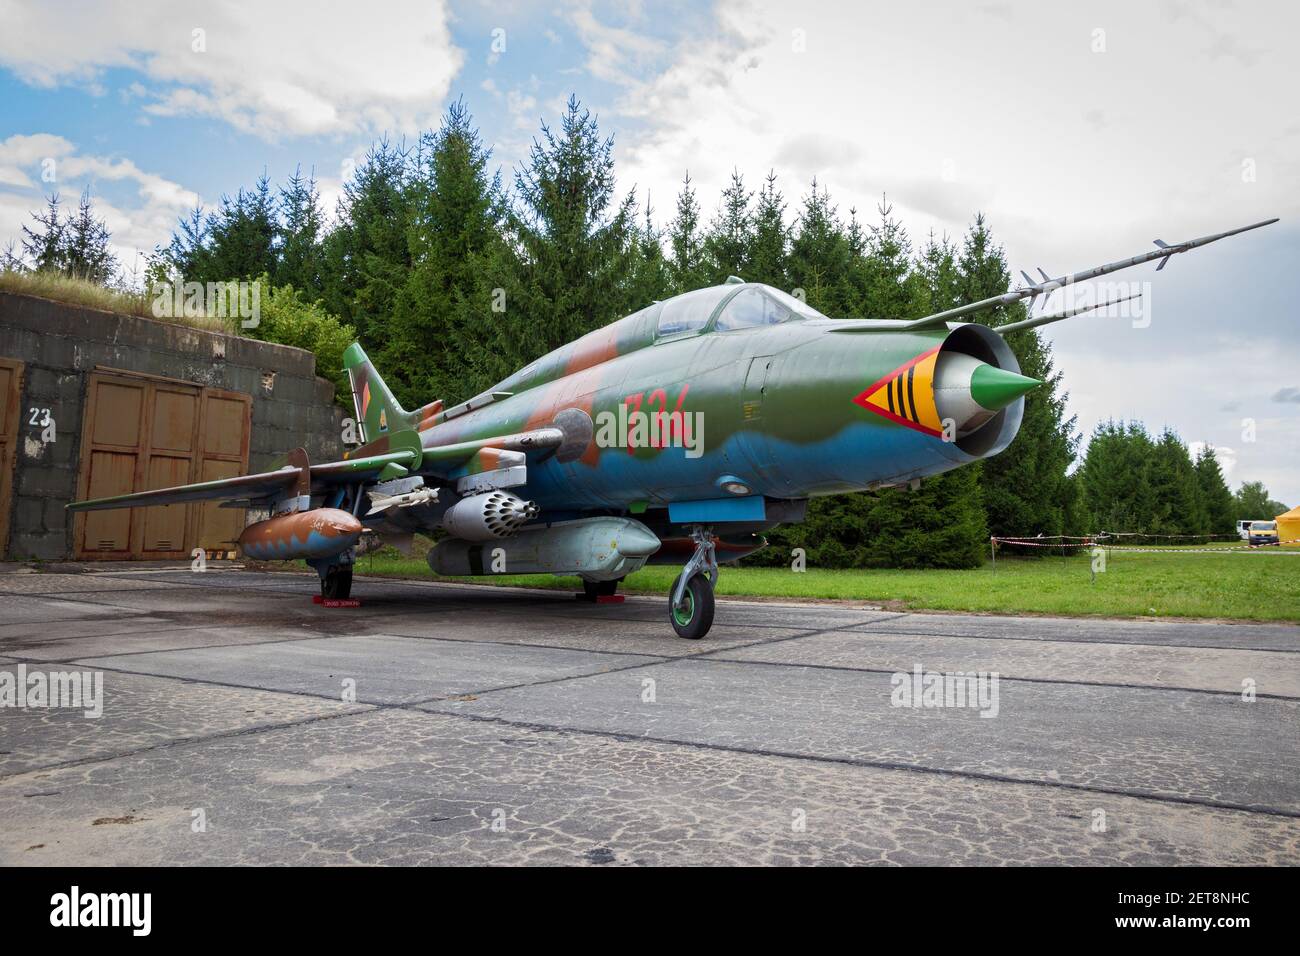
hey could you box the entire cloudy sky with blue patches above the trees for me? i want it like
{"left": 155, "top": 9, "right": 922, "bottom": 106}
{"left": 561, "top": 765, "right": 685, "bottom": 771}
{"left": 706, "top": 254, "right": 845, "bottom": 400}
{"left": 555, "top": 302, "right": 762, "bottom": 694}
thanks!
{"left": 0, "top": 0, "right": 1300, "bottom": 505}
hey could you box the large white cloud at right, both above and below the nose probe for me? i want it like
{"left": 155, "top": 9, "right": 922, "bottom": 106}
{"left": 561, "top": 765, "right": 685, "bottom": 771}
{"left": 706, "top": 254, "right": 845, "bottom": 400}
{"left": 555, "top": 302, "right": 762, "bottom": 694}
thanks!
{"left": 572, "top": 0, "right": 1300, "bottom": 499}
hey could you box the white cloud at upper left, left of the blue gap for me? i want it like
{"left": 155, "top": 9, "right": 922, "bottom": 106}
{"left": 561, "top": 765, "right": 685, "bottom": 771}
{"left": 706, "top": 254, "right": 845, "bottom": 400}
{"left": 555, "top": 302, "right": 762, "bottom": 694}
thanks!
{"left": 0, "top": 0, "right": 464, "bottom": 138}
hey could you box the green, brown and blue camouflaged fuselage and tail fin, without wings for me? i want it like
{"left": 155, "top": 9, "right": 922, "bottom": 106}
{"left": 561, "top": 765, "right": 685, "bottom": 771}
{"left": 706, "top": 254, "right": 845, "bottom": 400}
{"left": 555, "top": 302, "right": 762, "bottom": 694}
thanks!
{"left": 350, "top": 284, "right": 1023, "bottom": 514}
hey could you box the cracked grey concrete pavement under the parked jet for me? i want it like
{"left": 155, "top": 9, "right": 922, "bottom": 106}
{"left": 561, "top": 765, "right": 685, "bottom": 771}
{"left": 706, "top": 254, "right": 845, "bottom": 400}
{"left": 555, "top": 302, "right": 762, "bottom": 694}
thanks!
{"left": 0, "top": 564, "right": 1300, "bottom": 865}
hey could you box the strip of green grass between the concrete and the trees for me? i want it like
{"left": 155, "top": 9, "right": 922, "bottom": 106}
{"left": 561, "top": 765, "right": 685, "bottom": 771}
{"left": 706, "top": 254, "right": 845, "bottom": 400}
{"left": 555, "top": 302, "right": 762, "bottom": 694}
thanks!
{"left": 356, "top": 549, "right": 1300, "bottom": 622}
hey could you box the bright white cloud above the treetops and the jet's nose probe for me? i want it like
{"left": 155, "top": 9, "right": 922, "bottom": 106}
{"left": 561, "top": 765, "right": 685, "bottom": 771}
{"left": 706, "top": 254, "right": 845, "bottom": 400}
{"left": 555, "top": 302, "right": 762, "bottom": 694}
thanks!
{"left": 590, "top": 0, "right": 1300, "bottom": 274}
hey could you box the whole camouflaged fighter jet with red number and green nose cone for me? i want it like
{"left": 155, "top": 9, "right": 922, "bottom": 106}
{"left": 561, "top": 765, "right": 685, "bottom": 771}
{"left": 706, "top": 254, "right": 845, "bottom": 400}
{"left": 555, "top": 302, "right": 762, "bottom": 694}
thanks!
{"left": 68, "top": 220, "right": 1277, "bottom": 639}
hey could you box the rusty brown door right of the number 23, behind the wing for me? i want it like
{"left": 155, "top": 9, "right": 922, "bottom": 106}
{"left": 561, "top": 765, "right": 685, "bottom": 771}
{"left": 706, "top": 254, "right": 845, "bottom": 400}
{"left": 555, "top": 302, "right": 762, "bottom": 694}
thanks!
{"left": 74, "top": 372, "right": 252, "bottom": 559}
